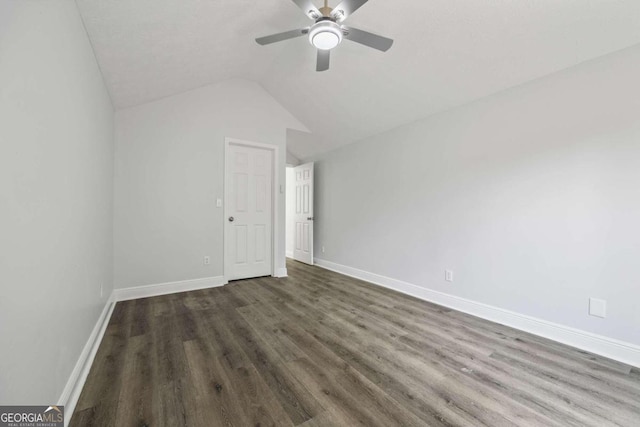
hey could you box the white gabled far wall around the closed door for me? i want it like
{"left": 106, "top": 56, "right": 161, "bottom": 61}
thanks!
{"left": 114, "top": 80, "right": 305, "bottom": 288}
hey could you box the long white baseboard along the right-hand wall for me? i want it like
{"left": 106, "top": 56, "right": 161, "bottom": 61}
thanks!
{"left": 314, "top": 258, "right": 640, "bottom": 367}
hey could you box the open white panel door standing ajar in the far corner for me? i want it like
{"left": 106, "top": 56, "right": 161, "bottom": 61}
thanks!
{"left": 293, "top": 163, "right": 313, "bottom": 265}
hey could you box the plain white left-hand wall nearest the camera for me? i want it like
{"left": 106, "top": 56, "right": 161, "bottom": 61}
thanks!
{"left": 0, "top": 0, "right": 113, "bottom": 405}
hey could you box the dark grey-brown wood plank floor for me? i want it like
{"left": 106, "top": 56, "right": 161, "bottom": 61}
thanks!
{"left": 71, "top": 262, "right": 640, "bottom": 427}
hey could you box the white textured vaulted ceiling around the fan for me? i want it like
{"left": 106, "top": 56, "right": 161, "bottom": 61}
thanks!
{"left": 76, "top": 0, "right": 640, "bottom": 158}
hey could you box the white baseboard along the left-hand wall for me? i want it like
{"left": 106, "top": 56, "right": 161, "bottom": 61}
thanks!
{"left": 58, "top": 293, "right": 116, "bottom": 426}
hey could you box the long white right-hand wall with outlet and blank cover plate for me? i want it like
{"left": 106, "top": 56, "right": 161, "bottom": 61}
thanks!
{"left": 315, "top": 46, "right": 640, "bottom": 344}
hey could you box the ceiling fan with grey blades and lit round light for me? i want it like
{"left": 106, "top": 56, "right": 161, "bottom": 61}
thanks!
{"left": 256, "top": 0, "right": 393, "bottom": 71}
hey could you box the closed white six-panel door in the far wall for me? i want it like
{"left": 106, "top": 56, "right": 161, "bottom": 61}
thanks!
{"left": 224, "top": 143, "right": 274, "bottom": 280}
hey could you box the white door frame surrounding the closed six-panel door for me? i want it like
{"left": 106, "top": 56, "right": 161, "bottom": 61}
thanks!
{"left": 222, "top": 137, "right": 280, "bottom": 283}
